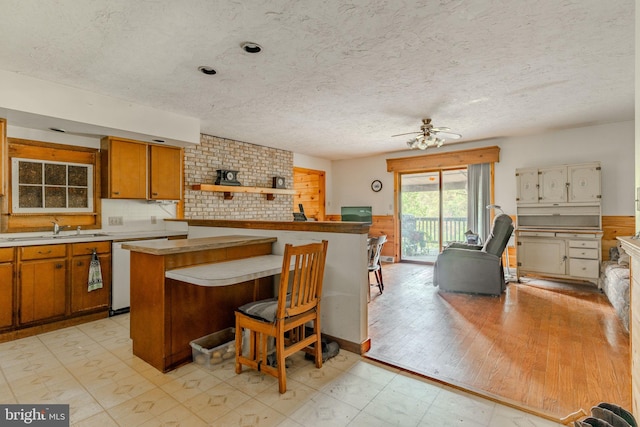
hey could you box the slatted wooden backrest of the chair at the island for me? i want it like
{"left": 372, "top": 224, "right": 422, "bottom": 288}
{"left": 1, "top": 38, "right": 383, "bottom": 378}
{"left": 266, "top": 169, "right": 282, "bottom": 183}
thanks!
{"left": 276, "top": 241, "right": 328, "bottom": 319}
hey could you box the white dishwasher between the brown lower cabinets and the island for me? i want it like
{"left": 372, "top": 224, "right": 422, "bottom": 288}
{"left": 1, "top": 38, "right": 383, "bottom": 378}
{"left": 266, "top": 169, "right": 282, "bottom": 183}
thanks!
{"left": 109, "top": 237, "right": 169, "bottom": 316}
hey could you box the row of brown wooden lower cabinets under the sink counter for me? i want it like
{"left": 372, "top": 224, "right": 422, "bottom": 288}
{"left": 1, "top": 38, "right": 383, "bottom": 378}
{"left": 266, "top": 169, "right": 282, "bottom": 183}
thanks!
{"left": 0, "top": 241, "right": 111, "bottom": 342}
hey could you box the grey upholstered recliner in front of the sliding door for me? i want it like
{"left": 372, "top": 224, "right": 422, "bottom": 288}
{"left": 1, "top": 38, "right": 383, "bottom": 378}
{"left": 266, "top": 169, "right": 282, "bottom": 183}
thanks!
{"left": 433, "top": 214, "right": 513, "bottom": 295}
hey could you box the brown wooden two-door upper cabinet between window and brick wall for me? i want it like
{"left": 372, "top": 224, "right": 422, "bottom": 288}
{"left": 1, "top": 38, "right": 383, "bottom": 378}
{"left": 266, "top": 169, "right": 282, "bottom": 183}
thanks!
{"left": 101, "top": 137, "right": 183, "bottom": 200}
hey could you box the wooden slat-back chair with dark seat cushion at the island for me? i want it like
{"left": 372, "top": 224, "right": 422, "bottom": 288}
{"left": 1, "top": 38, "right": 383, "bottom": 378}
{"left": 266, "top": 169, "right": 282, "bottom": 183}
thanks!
{"left": 235, "top": 240, "right": 328, "bottom": 393}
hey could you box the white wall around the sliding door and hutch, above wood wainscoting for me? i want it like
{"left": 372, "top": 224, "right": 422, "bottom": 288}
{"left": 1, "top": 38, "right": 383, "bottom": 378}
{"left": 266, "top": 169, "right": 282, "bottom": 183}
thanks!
{"left": 327, "top": 121, "right": 635, "bottom": 219}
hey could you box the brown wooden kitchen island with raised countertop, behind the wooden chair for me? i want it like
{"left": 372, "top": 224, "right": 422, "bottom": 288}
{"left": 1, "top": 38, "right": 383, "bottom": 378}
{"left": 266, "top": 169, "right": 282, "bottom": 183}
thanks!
{"left": 123, "top": 235, "right": 277, "bottom": 372}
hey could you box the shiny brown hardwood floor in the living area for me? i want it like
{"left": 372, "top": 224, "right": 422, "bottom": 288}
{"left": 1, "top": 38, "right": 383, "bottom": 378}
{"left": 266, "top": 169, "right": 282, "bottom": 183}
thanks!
{"left": 366, "top": 263, "right": 631, "bottom": 419}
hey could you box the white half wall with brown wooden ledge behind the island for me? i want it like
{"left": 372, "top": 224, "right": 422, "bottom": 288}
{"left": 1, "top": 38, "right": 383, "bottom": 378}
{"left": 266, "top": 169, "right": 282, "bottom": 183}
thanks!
{"left": 165, "top": 219, "right": 370, "bottom": 354}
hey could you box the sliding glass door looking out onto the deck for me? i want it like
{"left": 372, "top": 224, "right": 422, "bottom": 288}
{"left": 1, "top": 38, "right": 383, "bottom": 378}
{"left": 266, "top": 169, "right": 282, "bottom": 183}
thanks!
{"left": 400, "top": 168, "right": 467, "bottom": 263}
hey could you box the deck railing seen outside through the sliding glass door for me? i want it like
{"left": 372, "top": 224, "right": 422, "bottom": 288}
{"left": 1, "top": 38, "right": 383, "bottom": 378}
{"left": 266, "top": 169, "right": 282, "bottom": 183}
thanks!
{"left": 402, "top": 215, "right": 467, "bottom": 256}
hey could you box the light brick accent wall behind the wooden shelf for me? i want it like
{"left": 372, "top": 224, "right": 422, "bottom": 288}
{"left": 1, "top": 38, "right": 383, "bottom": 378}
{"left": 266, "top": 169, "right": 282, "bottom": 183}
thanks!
{"left": 184, "top": 135, "right": 293, "bottom": 221}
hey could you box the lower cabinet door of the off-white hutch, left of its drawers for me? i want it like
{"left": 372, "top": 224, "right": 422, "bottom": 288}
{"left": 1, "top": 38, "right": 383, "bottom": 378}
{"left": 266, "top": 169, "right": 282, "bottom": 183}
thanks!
{"left": 518, "top": 237, "right": 567, "bottom": 274}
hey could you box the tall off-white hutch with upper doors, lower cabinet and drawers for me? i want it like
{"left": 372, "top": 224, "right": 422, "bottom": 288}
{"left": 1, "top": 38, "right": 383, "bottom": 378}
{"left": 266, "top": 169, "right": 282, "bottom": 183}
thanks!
{"left": 516, "top": 162, "right": 602, "bottom": 284}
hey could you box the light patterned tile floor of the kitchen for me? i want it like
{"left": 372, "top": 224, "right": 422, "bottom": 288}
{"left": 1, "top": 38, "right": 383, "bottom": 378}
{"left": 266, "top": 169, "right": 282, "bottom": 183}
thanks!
{"left": 0, "top": 314, "right": 559, "bottom": 427}
